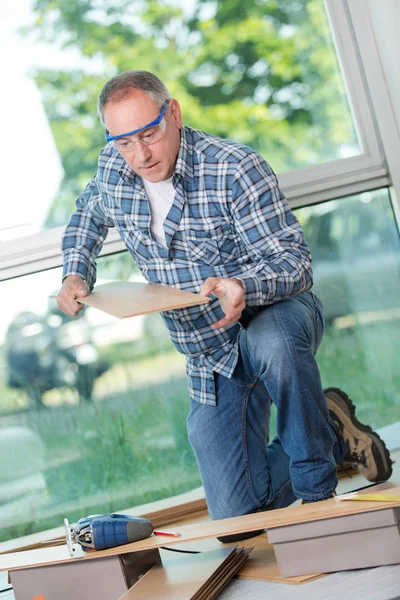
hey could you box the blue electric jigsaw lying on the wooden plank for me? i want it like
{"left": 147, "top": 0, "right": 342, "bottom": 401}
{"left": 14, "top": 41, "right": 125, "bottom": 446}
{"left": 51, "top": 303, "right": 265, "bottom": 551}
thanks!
{"left": 64, "top": 513, "right": 153, "bottom": 556}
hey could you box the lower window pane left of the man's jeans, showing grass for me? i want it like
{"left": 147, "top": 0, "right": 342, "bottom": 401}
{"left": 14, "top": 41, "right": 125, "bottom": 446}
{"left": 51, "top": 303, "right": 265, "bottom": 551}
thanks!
{"left": 0, "top": 254, "right": 200, "bottom": 541}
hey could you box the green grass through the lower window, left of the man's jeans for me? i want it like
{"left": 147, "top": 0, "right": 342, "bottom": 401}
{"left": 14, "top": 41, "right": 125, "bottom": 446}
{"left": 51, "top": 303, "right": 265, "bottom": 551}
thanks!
{"left": 0, "top": 378, "right": 201, "bottom": 541}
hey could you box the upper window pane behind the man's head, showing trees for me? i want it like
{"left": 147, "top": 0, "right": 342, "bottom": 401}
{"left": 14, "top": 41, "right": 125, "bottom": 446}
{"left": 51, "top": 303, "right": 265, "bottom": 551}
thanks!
{"left": 0, "top": 0, "right": 361, "bottom": 240}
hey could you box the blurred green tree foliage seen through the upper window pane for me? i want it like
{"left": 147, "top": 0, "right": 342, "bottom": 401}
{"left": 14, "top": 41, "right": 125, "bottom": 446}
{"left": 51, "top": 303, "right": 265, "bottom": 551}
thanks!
{"left": 29, "top": 0, "right": 356, "bottom": 226}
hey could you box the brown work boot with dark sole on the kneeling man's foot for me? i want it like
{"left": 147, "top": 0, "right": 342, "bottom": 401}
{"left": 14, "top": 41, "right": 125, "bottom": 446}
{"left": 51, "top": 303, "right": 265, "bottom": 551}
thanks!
{"left": 324, "top": 388, "right": 393, "bottom": 482}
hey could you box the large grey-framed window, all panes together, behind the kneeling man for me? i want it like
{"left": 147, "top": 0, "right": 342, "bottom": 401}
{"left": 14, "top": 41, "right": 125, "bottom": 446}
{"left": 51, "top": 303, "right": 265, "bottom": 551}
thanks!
{"left": 0, "top": 0, "right": 400, "bottom": 539}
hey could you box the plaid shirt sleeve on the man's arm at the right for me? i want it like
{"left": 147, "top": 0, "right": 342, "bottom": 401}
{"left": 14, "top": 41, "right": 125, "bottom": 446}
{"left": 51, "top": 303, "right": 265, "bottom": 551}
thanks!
{"left": 232, "top": 153, "right": 313, "bottom": 306}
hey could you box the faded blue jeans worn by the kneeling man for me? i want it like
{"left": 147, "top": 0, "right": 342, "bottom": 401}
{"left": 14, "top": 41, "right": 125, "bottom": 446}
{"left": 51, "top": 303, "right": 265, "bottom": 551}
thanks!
{"left": 187, "top": 292, "right": 345, "bottom": 519}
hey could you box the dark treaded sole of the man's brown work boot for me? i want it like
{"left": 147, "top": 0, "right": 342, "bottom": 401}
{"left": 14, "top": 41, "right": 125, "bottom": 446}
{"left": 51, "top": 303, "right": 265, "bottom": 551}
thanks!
{"left": 324, "top": 387, "right": 393, "bottom": 483}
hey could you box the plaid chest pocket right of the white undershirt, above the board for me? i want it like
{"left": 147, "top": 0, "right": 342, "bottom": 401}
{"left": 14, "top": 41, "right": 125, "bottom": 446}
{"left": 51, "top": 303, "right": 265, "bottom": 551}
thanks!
{"left": 185, "top": 223, "right": 239, "bottom": 265}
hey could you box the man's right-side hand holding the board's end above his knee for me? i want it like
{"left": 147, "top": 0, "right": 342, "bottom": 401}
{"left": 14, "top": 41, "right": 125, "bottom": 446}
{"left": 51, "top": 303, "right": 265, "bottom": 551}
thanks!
{"left": 200, "top": 277, "right": 246, "bottom": 329}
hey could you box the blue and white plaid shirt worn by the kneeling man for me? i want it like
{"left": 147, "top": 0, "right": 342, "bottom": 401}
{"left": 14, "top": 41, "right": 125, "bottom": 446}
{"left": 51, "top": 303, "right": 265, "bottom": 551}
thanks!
{"left": 62, "top": 127, "right": 312, "bottom": 404}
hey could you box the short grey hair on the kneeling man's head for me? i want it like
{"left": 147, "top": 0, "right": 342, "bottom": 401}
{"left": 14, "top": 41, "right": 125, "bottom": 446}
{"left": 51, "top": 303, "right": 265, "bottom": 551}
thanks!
{"left": 97, "top": 71, "right": 171, "bottom": 124}
